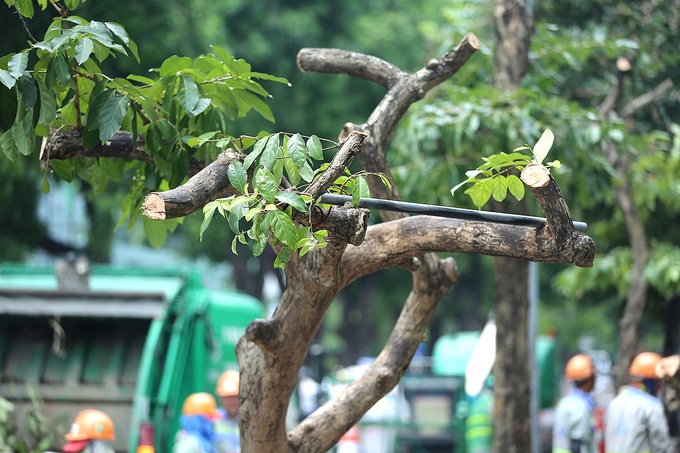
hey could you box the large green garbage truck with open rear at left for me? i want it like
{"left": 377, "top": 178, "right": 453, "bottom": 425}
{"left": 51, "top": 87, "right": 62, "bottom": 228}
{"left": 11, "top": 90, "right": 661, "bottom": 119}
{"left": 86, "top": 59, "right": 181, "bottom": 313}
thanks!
{"left": 0, "top": 261, "right": 264, "bottom": 453}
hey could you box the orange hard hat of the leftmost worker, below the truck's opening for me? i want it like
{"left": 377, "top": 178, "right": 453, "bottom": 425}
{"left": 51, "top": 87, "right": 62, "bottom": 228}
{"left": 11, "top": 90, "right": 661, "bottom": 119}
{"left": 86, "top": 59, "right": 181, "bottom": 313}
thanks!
{"left": 62, "top": 409, "right": 116, "bottom": 453}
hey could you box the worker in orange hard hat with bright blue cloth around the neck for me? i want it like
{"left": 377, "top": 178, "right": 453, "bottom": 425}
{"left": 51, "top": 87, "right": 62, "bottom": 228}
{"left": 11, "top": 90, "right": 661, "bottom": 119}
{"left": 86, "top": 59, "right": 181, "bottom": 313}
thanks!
{"left": 173, "top": 392, "right": 218, "bottom": 453}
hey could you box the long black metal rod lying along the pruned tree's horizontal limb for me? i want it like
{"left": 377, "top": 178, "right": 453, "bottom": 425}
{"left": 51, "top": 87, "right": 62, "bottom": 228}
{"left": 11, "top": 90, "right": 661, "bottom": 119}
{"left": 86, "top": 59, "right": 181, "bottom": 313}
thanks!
{"left": 321, "top": 193, "right": 588, "bottom": 232}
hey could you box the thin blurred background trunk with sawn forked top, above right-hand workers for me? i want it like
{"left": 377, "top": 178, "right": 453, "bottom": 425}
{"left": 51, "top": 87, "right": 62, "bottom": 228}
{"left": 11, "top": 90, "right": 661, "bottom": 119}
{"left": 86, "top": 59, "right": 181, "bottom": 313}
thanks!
{"left": 599, "top": 57, "right": 673, "bottom": 388}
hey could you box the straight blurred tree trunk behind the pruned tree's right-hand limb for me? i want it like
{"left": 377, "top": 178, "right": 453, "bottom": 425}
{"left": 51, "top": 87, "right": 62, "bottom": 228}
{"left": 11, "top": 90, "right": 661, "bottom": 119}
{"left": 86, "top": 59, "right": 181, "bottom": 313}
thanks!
{"left": 493, "top": 0, "right": 533, "bottom": 453}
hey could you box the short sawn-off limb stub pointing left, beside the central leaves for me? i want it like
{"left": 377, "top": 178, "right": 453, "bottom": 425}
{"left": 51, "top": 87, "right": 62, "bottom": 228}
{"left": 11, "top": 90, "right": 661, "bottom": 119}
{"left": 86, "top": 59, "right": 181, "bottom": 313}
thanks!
{"left": 142, "top": 151, "right": 241, "bottom": 220}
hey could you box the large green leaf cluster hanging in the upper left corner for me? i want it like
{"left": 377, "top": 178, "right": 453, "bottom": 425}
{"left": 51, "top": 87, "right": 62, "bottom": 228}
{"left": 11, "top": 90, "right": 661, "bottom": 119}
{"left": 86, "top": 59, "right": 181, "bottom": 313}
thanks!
{"left": 0, "top": 0, "right": 288, "bottom": 240}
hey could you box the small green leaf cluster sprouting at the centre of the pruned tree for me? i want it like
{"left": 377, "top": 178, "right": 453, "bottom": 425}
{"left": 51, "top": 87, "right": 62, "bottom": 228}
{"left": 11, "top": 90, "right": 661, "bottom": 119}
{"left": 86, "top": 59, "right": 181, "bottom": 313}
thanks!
{"left": 200, "top": 133, "right": 369, "bottom": 268}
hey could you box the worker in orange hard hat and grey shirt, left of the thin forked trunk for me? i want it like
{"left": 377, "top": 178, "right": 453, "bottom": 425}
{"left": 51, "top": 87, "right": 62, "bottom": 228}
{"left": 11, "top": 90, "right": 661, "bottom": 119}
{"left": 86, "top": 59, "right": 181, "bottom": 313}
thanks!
{"left": 552, "top": 354, "right": 597, "bottom": 453}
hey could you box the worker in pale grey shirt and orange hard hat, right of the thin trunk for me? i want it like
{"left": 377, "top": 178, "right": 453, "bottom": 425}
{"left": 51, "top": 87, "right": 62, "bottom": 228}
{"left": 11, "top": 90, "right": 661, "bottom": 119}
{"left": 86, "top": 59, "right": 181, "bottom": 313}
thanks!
{"left": 604, "top": 352, "right": 671, "bottom": 453}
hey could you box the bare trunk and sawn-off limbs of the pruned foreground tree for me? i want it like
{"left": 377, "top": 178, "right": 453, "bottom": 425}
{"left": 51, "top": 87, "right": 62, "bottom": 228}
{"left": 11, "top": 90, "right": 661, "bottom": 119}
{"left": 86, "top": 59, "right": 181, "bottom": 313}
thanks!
{"left": 43, "top": 34, "right": 595, "bottom": 452}
